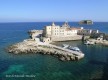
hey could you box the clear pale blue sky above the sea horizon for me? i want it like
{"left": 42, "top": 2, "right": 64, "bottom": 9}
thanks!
{"left": 0, "top": 0, "right": 108, "bottom": 22}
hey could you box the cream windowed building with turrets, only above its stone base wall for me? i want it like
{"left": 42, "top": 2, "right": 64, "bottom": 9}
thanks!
{"left": 43, "top": 22, "right": 83, "bottom": 37}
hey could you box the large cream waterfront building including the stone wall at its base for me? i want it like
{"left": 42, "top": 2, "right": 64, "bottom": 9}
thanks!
{"left": 43, "top": 22, "right": 83, "bottom": 42}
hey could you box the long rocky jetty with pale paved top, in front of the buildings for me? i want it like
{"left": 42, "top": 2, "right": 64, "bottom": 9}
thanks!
{"left": 7, "top": 39, "right": 84, "bottom": 61}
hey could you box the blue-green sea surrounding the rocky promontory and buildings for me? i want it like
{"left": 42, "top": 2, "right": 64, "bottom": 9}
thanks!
{"left": 0, "top": 22, "right": 108, "bottom": 80}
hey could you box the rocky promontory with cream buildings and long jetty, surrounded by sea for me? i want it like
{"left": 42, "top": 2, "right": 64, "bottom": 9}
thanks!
{"left": 7, "top": 22, "right": 99, "bottom": 61}
